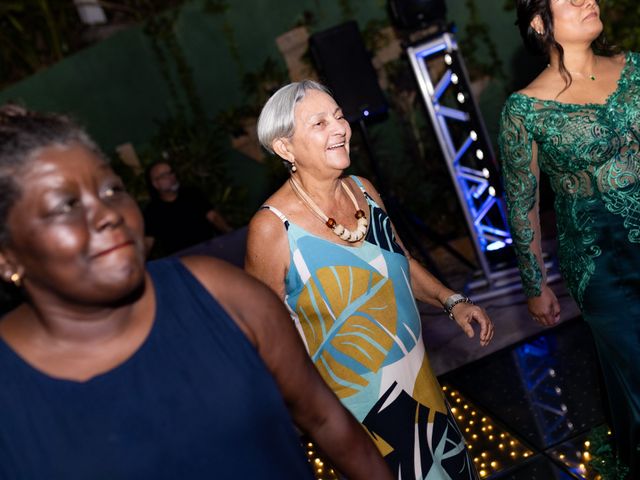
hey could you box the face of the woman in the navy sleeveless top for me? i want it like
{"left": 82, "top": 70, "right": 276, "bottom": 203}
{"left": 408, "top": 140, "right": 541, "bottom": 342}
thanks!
{"left": 0, "top": 145, "right": 144, "bottom": 306}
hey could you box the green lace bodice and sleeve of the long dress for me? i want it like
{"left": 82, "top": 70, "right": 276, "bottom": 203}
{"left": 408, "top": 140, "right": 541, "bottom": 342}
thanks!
{"left": 499, "top": 53, "right": 640, "bottom": 304}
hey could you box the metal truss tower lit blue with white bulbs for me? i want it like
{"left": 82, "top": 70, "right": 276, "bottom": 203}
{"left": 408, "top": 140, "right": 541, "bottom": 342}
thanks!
{"left": 407, "top": 32, "right": 556, "bottom": 299}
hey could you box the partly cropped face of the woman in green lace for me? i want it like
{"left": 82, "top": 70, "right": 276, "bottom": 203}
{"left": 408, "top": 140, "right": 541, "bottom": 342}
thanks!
{"left": 550, "top": 0, "right": 603, "bottom": 47}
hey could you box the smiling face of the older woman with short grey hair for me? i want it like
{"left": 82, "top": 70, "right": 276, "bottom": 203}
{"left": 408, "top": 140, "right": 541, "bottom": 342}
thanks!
{"left": 274, "top": 90, "right": 351, "bottom": 174}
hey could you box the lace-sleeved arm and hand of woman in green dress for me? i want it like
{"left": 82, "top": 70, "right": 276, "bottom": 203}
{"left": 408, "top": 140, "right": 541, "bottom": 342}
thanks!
{"left": 498, "top": 97, "right": 560, "bottom": 325}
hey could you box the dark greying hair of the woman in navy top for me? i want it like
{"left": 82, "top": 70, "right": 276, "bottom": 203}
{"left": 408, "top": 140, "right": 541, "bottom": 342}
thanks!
{"left": 0, "top": 104, "right": 106, "bottom": 247}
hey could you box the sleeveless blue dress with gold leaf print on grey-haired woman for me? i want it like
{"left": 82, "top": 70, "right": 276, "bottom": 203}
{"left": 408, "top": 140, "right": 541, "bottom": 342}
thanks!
{"left": 265, "top": 177, "right": 477, "bottom": 480}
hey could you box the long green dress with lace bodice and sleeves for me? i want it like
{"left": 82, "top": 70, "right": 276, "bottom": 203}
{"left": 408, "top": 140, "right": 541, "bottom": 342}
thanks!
{"left": 499, "top": 53, "right": 640, "bottom": 479}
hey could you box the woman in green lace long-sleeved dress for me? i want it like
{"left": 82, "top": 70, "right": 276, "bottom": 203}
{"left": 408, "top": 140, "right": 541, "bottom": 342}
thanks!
{"left": 499, "top": 0, "right": 640, "bottom": 479}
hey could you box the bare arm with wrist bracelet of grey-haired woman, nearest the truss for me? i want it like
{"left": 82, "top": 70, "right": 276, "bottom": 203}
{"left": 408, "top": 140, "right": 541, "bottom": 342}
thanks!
{"left": 360, "top": 178, "right": 493, "bottom": 346}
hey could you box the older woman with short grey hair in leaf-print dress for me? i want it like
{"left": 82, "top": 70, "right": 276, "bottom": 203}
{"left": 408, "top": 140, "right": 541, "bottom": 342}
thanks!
{"left": 246, "top": 81, "right": 493, "bottom": 479}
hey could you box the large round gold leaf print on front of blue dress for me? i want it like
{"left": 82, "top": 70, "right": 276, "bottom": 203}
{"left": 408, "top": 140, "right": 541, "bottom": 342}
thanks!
{"left": 297, "top": 266, "right": 397, "bottom": 398}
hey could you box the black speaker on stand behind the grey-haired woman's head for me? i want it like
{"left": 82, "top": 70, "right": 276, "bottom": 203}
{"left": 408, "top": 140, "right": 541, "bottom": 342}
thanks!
{"left": 309, "top": 21, "right": 388, "bottom": 122}
